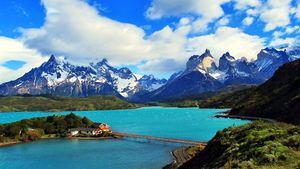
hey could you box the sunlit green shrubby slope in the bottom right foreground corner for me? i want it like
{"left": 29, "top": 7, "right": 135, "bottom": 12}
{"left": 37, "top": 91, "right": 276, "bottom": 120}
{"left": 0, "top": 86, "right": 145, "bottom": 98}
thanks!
{"left": 181, "top": 122, "right": 300, "bottom": 169}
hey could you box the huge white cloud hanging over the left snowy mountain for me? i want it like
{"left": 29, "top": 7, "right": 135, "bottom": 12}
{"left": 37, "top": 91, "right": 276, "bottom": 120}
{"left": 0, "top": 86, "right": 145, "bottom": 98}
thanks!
{"left": 22, "top": 0, "right": 150, "bottom": 64}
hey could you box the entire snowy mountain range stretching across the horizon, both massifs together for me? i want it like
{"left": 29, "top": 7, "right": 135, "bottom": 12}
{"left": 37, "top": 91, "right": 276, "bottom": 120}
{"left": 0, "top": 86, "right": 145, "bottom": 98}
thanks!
{"left": 0, "top": 47, "right": 300, "bottom": 102}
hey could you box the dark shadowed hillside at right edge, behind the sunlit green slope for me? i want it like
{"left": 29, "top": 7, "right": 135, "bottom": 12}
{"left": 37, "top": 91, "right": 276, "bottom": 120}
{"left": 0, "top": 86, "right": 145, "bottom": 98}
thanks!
{"left": 199, "top": 60, "right": 300, "bottom": 124}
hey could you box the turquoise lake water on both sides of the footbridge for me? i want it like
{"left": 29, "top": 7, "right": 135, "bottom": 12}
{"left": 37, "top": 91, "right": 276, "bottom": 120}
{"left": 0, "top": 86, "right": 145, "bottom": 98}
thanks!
{"left": 0, "top": 107, "right": 248, "bottom": 169}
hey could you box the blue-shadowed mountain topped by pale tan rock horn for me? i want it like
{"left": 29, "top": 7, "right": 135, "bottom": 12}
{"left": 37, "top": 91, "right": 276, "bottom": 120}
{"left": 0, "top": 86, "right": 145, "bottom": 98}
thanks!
{"left": 147, "top": 50, "right": 222, "bottom": 100}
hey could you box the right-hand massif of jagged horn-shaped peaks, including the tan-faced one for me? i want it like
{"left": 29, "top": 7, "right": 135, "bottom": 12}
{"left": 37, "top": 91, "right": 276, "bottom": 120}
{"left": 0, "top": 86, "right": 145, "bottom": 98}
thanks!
{"left": 147, "top": 47, "right": 300, "bottom": 100}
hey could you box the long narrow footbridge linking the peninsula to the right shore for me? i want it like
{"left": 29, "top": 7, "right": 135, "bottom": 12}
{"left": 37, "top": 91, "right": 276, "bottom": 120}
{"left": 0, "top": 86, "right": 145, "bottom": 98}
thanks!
{"left": 113, "top": 132, "right": 207, "bottom": 146}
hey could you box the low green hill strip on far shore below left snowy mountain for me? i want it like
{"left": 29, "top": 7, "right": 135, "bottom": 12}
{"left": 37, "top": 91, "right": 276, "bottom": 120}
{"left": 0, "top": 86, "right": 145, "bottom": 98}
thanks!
{"left": 0, "top": 96, "right": 137, "bottom": 112}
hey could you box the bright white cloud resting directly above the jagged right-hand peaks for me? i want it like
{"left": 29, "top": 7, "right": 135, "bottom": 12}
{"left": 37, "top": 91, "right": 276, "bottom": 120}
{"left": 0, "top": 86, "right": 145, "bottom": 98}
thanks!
{"left": 187, "top": 27, "right": 265, "bottom": 61}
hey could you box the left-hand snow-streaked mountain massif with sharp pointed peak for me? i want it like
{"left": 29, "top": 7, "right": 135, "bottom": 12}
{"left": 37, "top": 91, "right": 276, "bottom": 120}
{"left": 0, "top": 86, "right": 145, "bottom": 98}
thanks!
{"left": 0, "top": 56, "right": 164, "bottom": 98}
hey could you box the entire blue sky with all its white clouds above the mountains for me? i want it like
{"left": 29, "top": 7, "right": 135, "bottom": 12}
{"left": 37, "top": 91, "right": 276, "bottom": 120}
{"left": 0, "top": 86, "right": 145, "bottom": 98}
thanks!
{"left": 0, "top": 0, "right": 300, "bottom": 82}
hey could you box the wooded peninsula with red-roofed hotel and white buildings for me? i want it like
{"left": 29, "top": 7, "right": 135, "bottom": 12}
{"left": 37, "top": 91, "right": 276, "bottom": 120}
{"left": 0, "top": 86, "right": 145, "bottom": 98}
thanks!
{"left": 0, "top": 113, "right": 113, "bottom": 146}
